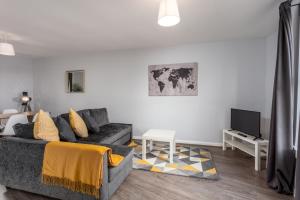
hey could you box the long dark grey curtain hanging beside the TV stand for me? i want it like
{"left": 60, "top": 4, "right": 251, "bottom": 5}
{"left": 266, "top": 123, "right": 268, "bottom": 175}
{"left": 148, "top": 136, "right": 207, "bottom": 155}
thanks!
{"left": 267, "top": 1, "right": 299, "bottom": 194}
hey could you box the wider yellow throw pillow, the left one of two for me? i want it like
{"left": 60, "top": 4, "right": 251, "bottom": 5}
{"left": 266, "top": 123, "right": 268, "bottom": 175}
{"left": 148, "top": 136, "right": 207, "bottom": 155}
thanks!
{"left": 33, "top": 110, "right": 59, "bottom": 141}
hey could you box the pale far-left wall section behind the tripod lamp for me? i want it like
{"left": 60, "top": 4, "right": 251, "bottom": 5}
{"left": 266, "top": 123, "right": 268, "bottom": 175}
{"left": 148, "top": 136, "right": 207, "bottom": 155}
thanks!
{"left": 0, "top": 56, "right": 33, "bottom": 112}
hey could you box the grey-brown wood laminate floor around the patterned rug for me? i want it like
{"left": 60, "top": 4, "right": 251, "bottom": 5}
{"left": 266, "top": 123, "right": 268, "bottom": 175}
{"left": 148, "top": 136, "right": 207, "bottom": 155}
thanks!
{"left": 0, "top": 147, "right": 293, "bottom": 200}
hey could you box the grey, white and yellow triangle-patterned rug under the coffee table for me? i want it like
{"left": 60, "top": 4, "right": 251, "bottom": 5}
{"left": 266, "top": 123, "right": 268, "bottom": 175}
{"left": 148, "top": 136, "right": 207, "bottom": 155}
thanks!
{"left": 133, "top": 141, "right": 219, "bottom": 180}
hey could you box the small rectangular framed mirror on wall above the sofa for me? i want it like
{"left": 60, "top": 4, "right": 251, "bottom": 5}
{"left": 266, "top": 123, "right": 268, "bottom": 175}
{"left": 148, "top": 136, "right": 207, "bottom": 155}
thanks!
{"left": 65, "top": 70, "right": 85, "bottom": 93}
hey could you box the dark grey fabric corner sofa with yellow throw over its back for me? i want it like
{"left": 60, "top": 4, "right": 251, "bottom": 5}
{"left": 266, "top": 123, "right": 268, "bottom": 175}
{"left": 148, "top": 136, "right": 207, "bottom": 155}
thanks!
{"left": 0, "top": 109, "right": 133, "bottom": 200}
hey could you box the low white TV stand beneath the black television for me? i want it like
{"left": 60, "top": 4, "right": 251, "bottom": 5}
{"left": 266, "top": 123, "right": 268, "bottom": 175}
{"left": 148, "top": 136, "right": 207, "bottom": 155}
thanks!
{"left": 223, "top": 129, "right": 269, "bottom": 171}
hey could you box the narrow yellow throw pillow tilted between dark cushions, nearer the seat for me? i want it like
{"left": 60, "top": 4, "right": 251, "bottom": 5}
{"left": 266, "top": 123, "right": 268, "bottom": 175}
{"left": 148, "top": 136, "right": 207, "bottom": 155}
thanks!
{"left": 69, "top": 108, "right": 88, "bottom": 138}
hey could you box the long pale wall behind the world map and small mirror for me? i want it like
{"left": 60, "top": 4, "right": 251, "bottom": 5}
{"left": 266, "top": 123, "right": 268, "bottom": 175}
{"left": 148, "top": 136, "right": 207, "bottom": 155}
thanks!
{"left": 34, "top": 39, "right": 267, "bottom": 142}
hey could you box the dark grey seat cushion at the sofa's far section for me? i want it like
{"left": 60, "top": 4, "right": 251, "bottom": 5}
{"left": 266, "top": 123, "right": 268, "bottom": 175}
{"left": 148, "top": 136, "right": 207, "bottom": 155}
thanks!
{"left": 79, "top": 123, "right": 132, "bottom": 144}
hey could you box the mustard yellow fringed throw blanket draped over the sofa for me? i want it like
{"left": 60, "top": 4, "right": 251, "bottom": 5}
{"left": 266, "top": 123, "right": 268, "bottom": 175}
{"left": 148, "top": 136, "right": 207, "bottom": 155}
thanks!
{"left": 42, "top": 142, "right": 124, "bottom": 199}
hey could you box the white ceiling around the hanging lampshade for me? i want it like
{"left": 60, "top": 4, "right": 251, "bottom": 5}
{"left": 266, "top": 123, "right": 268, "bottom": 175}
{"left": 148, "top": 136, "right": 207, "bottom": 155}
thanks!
{"left": 0, "top": 0, "right": 280, "bottom": 57}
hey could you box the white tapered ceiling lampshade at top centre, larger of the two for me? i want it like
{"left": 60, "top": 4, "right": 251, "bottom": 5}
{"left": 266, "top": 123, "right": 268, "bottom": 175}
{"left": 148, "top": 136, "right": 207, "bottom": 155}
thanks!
{"left": 158, "top": 0, "right": 180, "bottom": 27}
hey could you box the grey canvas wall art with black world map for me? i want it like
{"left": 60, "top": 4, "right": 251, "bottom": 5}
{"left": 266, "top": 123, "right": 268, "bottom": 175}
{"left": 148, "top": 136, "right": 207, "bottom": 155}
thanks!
{"left": 148, "top": 63, "right": 198, "bottom": 96}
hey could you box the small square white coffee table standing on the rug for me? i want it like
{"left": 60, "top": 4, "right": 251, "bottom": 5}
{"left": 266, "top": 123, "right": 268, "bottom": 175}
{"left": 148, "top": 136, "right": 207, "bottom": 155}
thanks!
{"left": 142, "top": 129, "right": 176, "bottom": 163}
